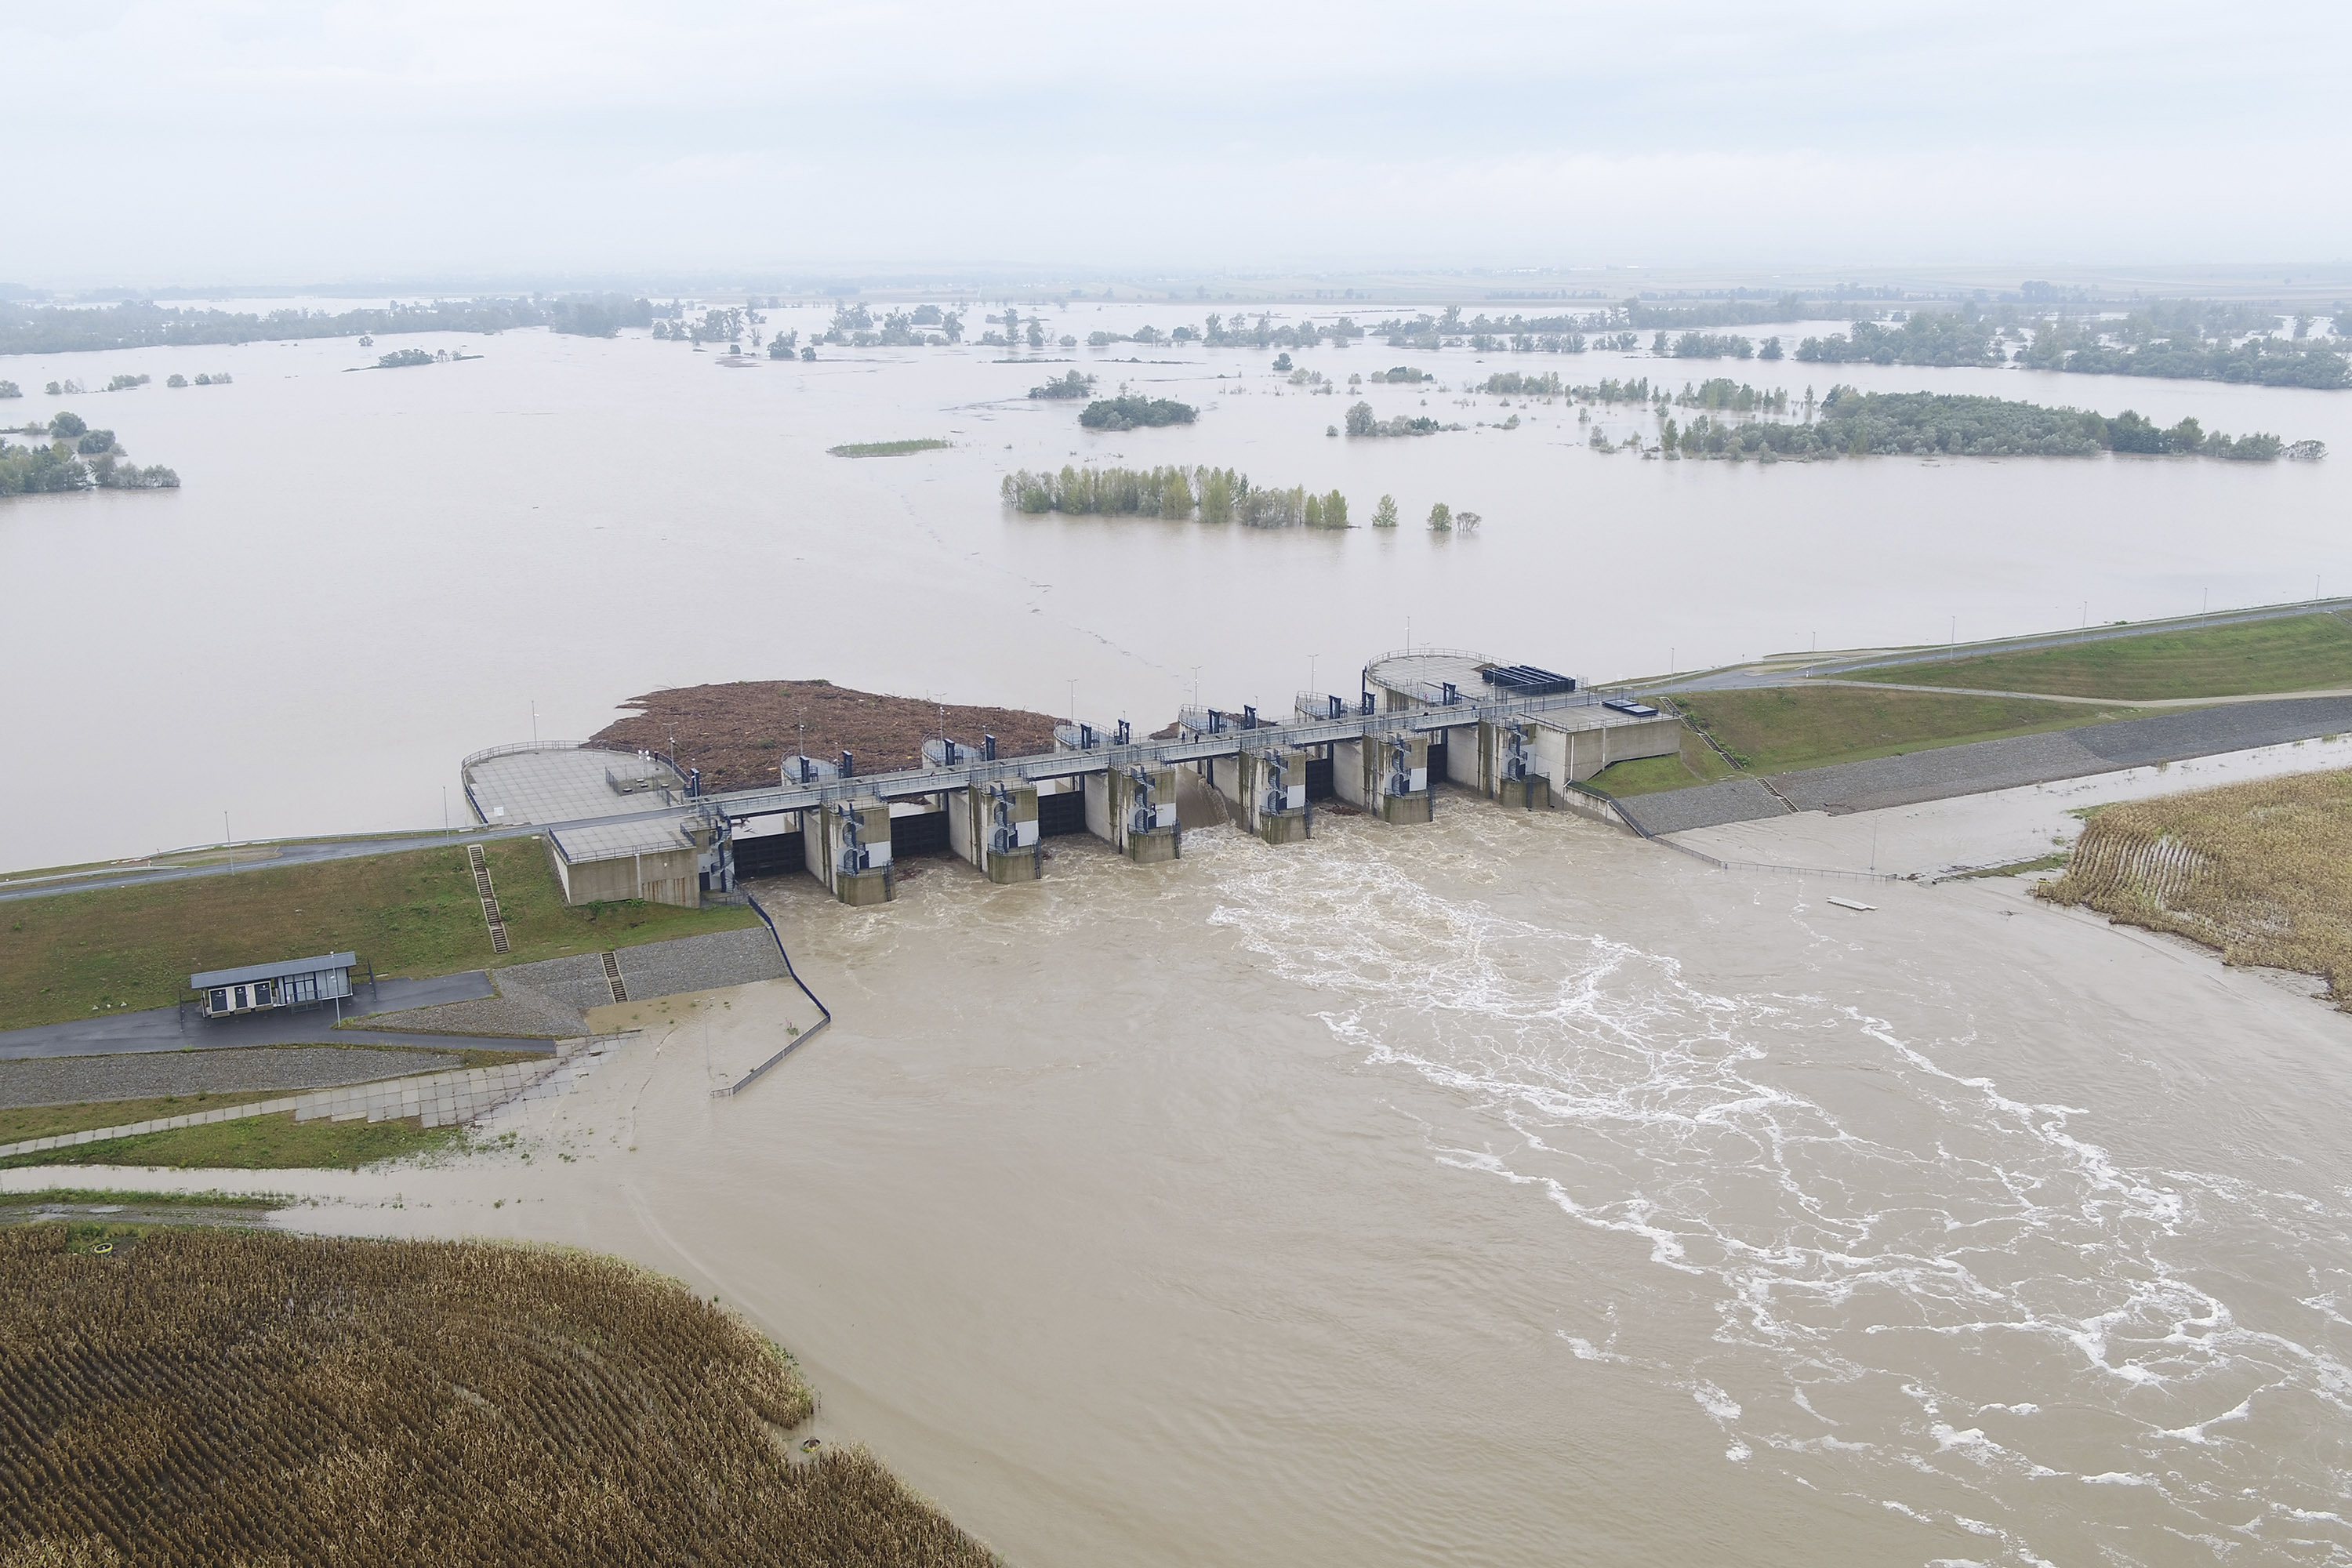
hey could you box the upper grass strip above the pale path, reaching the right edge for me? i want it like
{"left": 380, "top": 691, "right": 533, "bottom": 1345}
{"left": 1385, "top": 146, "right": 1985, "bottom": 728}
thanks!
{"left": 1846, "top": 614, "right": 2352, "bottom": 703}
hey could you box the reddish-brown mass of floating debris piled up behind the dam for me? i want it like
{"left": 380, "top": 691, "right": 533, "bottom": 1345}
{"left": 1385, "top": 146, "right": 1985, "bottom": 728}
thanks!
{"left": 595, "top": 680, "right": 1054, "bottom": 789}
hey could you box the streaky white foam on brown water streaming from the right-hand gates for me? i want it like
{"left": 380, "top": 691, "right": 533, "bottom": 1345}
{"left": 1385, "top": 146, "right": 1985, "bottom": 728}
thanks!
{"left": 1188, "top": 813, "right": 2352, "bottom": 1563}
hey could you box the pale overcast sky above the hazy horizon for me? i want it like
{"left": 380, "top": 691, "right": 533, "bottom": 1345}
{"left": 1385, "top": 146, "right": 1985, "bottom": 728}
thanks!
{"left": 0, "top": 0, "right": 2352, "bottom": 287}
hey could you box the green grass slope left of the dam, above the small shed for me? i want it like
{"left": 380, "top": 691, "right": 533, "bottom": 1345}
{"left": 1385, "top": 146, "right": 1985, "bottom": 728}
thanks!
{"left": 0, "top": 839, "right": 757, "bottom": 1039}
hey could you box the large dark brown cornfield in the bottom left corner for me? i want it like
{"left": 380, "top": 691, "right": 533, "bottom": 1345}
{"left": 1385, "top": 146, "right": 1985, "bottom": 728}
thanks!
{"left": 0, "top": 1225, "right": 995, "bottom": 1568}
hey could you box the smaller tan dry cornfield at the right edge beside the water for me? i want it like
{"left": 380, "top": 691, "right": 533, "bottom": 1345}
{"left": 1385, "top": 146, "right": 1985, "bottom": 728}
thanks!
{"left": 2034, "top": 774, "right": 2352, "bottom": 1011}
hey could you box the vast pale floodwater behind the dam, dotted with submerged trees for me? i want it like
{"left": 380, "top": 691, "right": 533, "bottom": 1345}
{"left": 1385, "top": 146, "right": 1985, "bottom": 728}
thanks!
{"left": 0, "top": 301, "right": 2352, "bottom": 867}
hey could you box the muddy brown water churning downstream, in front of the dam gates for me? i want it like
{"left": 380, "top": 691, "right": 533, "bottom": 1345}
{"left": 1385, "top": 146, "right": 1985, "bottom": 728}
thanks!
{"left": 111, "top": 801, "right": 2352, "bottom": 1566}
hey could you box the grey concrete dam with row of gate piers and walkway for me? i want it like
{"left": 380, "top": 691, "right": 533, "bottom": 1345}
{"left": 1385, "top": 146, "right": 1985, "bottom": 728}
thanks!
{"left": 463, "top": 649, "right": 1682, "bottom": 905}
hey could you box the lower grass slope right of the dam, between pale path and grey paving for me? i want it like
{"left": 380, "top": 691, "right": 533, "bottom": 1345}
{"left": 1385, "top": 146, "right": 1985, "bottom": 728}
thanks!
{"left": 1675, "top": 687, "right": 2138, "bottom": 774}
